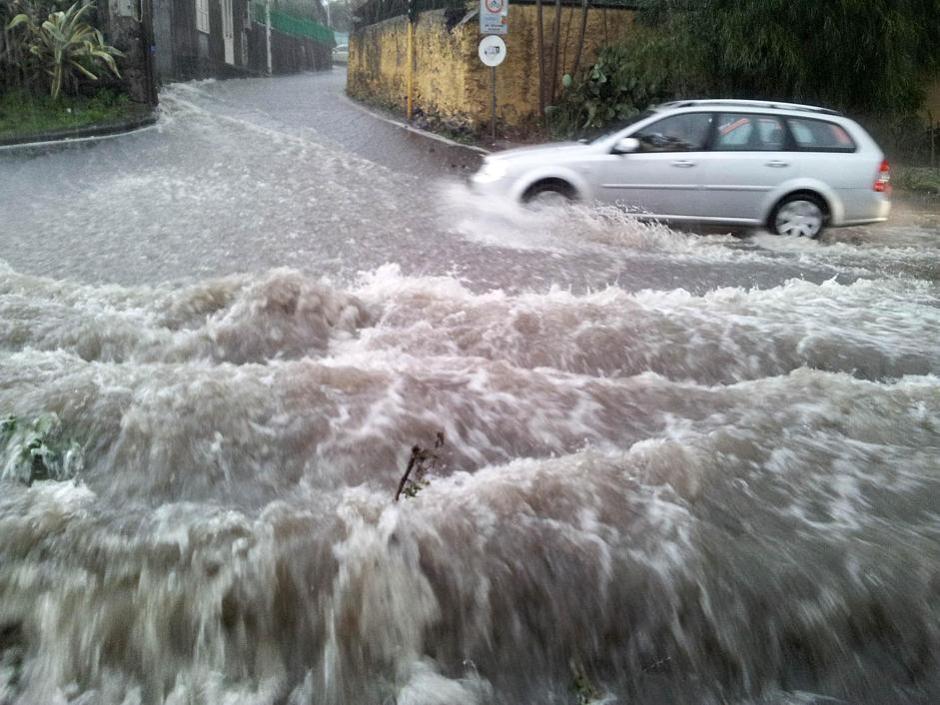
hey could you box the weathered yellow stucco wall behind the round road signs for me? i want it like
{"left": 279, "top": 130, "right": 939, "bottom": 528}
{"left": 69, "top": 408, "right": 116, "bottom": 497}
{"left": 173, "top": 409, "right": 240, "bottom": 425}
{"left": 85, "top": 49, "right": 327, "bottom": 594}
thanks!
{"left": 347, "top": 5, "right": 633, "bottom": 129}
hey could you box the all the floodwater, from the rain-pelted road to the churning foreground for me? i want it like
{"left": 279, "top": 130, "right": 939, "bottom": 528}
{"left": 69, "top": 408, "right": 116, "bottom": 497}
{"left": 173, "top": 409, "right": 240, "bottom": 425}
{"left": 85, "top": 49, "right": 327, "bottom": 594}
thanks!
{"left": 0, "top": 71, "right": 940, "bottom": 705}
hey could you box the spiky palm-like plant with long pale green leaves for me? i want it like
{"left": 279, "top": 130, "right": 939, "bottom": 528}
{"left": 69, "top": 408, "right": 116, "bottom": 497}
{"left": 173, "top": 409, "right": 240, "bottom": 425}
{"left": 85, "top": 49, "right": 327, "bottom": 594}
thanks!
{"left": 8, "top": 0, "right": 124, "bottom": 99}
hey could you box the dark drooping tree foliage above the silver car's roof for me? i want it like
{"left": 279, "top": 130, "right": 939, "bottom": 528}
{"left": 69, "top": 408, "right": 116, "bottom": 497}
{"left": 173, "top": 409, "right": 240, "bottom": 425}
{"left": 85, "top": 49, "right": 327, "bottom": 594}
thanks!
{"left": 640, "top": 0, "right": 940, "bottom": 114}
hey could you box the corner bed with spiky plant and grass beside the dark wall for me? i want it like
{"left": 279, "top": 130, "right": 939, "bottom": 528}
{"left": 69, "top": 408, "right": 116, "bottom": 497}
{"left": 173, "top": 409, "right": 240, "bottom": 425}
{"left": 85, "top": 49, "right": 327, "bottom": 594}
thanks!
{"left": 0, "top": 0, "right": 144, "bottom": 140}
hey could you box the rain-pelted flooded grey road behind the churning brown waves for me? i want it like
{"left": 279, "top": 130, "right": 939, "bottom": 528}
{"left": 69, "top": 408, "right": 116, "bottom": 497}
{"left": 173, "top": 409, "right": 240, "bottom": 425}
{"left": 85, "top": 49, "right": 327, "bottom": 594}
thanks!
{"left": 0, "top": 70, "right": 940, "bottom": 292}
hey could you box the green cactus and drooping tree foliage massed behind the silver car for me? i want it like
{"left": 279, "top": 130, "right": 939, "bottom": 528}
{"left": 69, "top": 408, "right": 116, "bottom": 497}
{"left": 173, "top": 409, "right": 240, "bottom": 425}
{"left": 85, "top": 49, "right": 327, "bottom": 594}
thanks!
{"left": 546, "top": 0, "right": 940, "bottom": 160}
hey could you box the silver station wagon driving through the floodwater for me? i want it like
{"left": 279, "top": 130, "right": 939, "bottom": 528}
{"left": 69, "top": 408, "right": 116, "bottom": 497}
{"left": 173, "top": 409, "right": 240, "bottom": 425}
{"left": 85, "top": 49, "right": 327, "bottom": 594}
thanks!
{"left": 471, "top": 100, "right": 891, "bottom": 237}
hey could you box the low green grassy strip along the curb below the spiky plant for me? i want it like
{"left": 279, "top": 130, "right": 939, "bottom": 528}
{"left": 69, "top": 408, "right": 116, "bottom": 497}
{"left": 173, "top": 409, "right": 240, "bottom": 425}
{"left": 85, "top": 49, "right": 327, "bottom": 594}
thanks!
{"left": 0, "top": 90, "right": 149, "bottom": 141}
